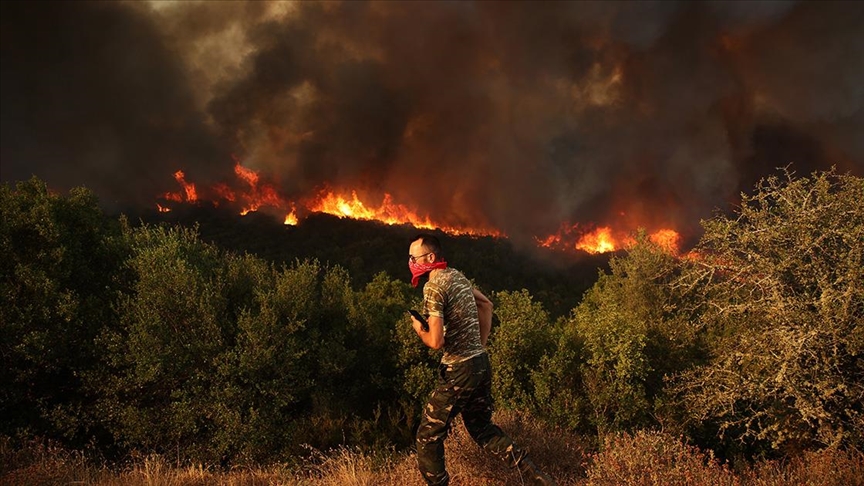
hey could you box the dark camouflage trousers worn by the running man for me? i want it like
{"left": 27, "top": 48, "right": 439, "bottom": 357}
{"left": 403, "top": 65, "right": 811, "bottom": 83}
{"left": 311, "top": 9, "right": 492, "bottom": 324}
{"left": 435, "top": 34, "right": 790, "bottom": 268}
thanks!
{"left": 417, "top": 353, "right": 525, "bottom": 485}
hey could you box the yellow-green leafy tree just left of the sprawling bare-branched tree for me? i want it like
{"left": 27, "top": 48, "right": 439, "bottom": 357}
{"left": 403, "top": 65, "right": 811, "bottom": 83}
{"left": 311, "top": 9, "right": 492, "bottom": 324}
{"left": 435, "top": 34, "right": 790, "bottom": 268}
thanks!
{"left": 568, "top": 232, "right": 698, "bottom": 430}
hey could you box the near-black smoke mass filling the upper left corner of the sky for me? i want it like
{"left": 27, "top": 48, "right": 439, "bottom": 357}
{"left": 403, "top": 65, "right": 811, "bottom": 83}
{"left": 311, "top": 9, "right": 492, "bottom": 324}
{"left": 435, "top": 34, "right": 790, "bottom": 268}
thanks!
{"left": 0, "top": 2, "right": 230, "bottom": 203}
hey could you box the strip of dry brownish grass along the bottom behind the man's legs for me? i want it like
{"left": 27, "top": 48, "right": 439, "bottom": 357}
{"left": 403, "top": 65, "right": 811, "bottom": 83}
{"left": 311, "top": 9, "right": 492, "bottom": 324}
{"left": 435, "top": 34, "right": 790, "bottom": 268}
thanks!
{"left": 0, "top": 412, "right": 864, "bottom": 486}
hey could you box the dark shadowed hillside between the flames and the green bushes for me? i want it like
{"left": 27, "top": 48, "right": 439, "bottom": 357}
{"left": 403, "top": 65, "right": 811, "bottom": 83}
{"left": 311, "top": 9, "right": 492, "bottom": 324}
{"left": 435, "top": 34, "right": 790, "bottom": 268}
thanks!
{"left": 137, "top": 205, "right": 609, "bottom": 317}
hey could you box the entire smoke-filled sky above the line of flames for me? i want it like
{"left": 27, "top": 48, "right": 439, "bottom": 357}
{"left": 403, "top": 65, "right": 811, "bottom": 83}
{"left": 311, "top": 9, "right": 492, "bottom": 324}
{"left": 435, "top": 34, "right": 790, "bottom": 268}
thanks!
{"left": 0, "top": 1, "right": 864, "bottom": 243}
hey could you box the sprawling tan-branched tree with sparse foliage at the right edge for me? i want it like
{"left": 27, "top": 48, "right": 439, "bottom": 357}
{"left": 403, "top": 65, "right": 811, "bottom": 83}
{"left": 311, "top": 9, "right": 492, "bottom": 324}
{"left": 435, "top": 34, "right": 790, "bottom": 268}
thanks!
{"left": 677, "top": 171, "right": 864, "bottom": 449}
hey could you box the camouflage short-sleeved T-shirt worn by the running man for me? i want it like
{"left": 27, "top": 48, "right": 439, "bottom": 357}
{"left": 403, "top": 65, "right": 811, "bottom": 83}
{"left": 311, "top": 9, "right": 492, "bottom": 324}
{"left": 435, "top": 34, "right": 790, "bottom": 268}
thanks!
{"left": 423, "top": 268, "right": 485, "bottom": 364}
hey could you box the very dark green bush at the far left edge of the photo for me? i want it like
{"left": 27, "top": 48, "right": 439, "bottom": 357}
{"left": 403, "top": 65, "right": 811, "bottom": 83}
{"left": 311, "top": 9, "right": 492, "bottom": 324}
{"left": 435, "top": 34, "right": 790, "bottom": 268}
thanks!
{"left": 0, "top": 178, "right": 128, "bottom": 444}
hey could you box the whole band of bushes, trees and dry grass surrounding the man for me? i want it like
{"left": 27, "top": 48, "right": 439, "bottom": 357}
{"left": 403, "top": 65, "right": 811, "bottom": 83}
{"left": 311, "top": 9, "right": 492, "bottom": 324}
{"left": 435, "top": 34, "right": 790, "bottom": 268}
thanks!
{"left": 0, "top": 171, "right": 864, "bottom": 484}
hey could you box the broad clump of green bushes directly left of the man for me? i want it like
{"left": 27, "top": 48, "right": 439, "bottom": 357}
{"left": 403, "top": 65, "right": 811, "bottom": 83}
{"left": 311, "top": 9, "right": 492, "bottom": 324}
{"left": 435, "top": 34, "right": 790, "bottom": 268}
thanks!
{"left": 91, "top": 225, "right": 418, "bottom": 463}
